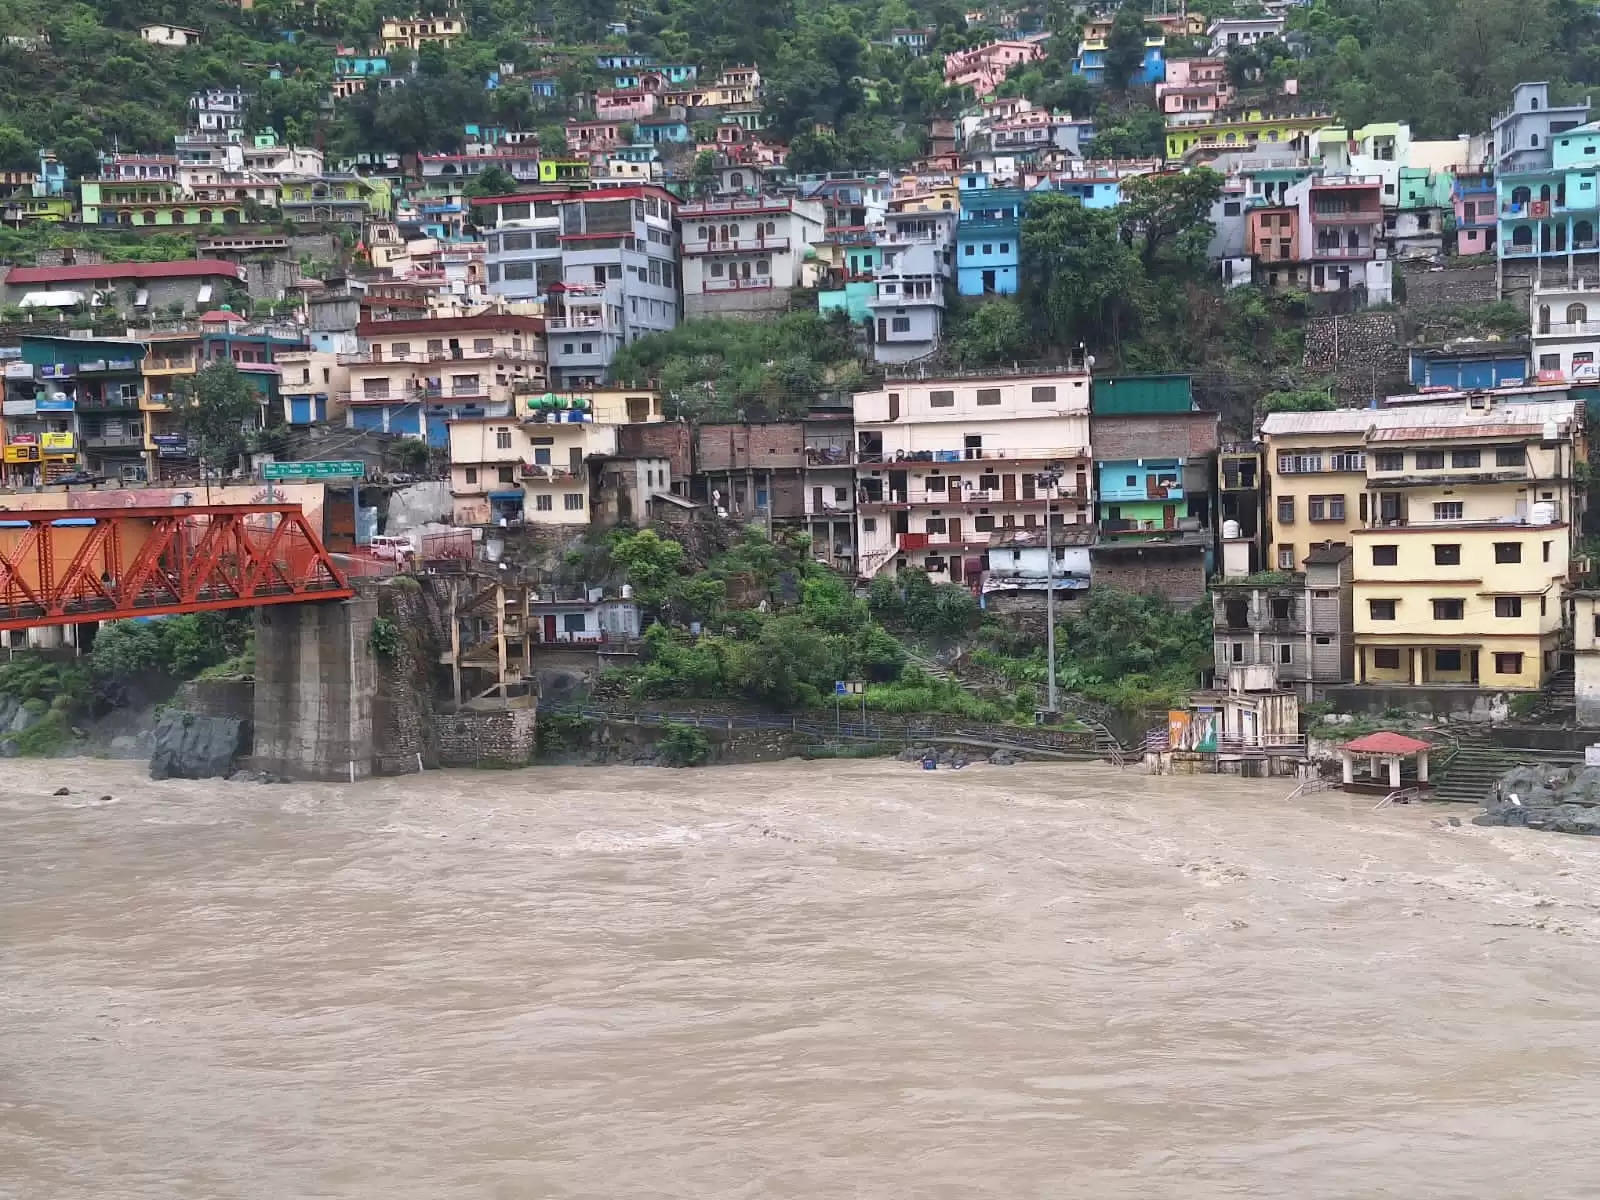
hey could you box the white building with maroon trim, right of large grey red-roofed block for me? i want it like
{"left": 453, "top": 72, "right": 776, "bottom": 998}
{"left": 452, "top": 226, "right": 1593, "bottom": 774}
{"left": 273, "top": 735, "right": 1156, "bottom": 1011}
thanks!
{"left": 677, "top": 197, "right": 824, "bottom": 317}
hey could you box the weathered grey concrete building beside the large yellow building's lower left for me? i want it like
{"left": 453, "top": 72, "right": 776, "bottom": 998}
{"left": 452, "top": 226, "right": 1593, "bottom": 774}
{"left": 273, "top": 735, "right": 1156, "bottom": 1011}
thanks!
{"left": 1211, "top": 546, "right": 1355, "bottom": 699}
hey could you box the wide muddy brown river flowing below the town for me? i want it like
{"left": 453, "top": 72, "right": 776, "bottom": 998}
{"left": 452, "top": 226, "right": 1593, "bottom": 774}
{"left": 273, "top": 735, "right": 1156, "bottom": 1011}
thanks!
{"left": 0, "top": 762, "right": 1600, "bottom": 1200}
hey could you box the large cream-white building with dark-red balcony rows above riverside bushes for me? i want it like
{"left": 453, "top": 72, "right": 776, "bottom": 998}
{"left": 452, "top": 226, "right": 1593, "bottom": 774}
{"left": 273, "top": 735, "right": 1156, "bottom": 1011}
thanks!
{"left": 854, "top": 366, "right": 1093, "bottom": 581}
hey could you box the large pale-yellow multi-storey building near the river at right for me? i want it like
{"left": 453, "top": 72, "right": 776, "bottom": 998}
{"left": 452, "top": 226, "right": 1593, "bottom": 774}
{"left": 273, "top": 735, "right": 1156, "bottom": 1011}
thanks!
{"left": 1262, "top": 395, "right": 1586, "bottom": 690}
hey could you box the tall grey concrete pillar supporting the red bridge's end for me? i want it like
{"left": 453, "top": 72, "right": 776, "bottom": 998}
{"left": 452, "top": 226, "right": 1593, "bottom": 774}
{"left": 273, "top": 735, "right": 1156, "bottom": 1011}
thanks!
{"left": 254, "top": 597, "right": 378, "bottom": 781}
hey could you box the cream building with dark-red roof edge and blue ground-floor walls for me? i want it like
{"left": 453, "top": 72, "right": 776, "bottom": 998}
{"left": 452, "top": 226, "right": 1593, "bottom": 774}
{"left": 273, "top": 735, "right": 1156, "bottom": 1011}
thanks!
{"left": 340, "top": 312, "right": 546, "bottom": 448}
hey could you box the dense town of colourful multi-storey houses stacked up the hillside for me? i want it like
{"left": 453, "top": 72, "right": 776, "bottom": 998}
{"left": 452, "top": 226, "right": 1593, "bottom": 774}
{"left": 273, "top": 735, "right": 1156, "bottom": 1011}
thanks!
{"left": 0, "top": 3, "right": 1600, "bottom": 790}
